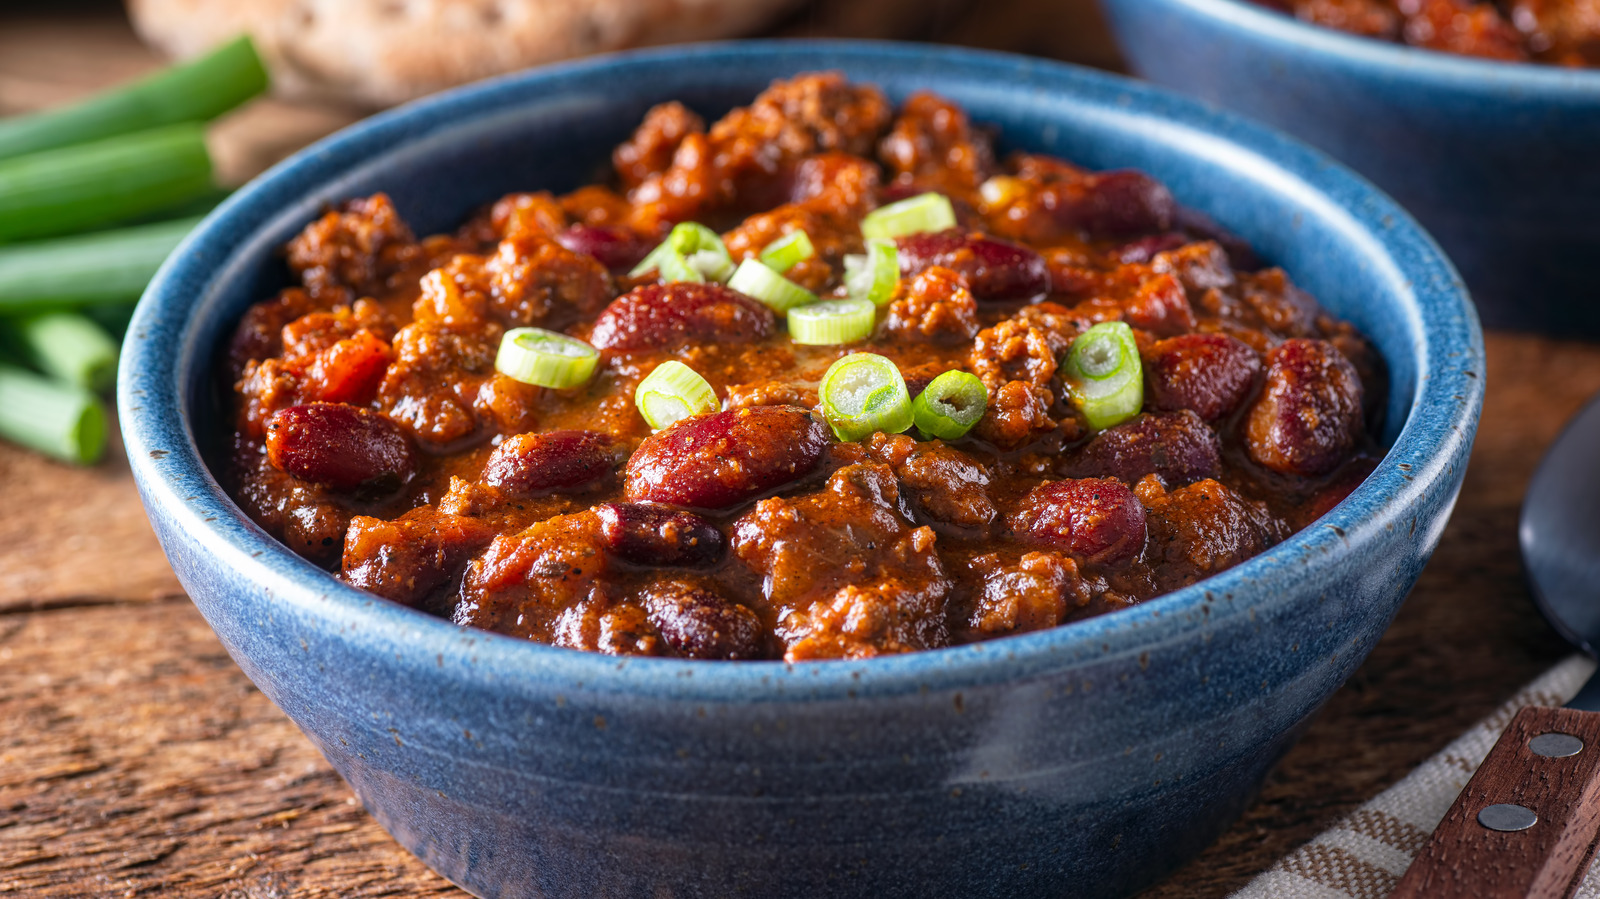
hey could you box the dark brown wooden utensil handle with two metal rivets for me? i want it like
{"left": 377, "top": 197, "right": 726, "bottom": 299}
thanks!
{"left": 1392, "top": 705, "right": 1600, "bottom": 899}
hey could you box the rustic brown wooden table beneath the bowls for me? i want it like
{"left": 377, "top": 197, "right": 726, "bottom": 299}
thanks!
{"left": 0, "top": 0, "right": 1574, "bottom": 899}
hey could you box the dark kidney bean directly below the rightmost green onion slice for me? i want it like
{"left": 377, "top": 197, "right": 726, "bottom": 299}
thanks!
{"left": 1067, "top": 410, "right": 1222, "bottom": 485}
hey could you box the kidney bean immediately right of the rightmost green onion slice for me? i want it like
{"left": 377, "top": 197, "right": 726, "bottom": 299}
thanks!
{"left": 1144, "top": 334, "right": 1261, "bottom": 421}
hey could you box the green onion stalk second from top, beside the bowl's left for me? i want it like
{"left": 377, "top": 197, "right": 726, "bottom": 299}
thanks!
{"left": 0, "top": 123, "right": 213, "bottom": 243}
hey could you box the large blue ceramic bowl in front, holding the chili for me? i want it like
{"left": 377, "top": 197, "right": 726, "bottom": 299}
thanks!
{"left": 118, "top": 42, "right": 1483, "bottom": 897}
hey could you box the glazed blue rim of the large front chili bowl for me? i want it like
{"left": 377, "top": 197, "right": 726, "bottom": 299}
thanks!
{"left": 117, "top": 40, "right": 1483, "bottom": 704}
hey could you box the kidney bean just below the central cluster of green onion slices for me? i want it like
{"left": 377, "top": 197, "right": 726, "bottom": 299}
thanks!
{"left": 589, "top": 282, "right": 778, "bottom": 350}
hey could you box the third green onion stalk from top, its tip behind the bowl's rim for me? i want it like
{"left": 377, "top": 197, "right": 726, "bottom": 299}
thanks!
{"left": 0, "top": 218, "right": 200, "bottom": 312}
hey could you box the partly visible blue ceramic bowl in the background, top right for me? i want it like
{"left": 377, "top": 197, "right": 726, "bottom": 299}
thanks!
{"left": 1102, "top": 0, "right": 1600, "bottom": 338}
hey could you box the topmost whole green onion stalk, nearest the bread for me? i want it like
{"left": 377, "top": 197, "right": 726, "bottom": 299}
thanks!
{"left": 0, "top": 37, "right": 267, "bottom": 158}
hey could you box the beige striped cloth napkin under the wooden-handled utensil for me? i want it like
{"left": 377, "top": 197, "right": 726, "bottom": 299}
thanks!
{"left": 1232, "top": 656, "right": 1600, "bottom": 899}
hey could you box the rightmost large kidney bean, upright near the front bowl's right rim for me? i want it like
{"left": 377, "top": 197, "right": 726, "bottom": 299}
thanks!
{"left": 1245, "top": 338, "right": 1362, "bottom": 475}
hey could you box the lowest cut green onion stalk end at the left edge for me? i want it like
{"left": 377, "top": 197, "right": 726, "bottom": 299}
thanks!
{"left": 0, "top": 365, "right": 106, "bottom": 465}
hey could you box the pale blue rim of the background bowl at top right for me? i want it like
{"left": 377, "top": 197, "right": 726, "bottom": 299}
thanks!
{"left": 1152, "top": 0, "right": 1600, "bottom": 91}
